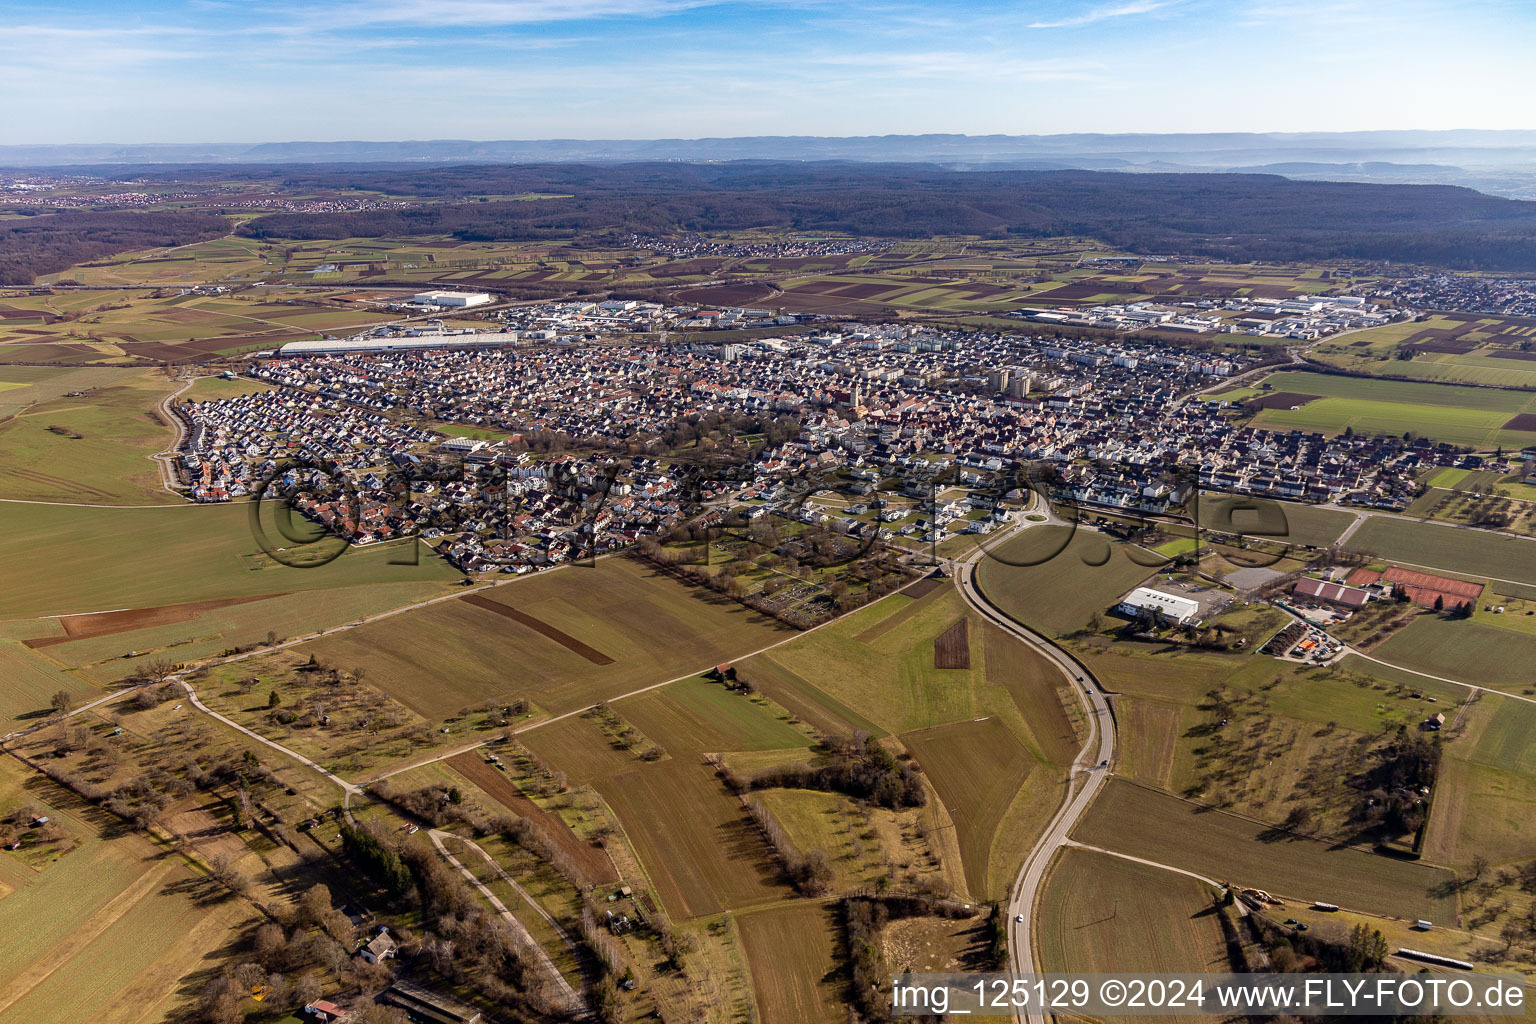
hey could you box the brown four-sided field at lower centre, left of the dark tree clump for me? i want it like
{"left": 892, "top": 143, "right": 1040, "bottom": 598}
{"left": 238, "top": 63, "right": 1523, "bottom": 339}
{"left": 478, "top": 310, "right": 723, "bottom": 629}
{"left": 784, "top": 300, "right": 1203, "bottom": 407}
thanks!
{"left": 596, "top": 758, "right": 788, "bottom": 918}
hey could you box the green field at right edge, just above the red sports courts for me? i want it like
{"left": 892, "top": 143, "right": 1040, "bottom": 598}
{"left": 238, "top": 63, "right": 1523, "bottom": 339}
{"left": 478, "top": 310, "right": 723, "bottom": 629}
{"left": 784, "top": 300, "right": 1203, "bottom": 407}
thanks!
{"left": 1344, "top": 516, "right": 1536, "bottom": 585}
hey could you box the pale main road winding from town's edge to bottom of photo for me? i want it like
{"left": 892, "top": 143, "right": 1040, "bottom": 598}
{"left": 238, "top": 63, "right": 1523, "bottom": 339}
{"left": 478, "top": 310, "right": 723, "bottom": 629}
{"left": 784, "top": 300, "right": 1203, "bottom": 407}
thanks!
{"left": 954, "top": 528, "right": 1115, "bottom": 1024}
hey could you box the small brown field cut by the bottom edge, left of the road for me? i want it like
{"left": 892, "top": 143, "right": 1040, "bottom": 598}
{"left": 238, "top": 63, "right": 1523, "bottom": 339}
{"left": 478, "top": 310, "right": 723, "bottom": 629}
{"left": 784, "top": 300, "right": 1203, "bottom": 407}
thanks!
{"left": 736, "top": 903, "right": 848, "bottom": 1024}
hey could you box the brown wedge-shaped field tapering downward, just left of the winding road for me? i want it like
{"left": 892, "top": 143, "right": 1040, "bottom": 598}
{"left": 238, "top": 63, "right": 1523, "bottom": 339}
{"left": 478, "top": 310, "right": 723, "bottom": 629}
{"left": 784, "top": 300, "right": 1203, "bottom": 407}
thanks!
{"left": 902, "top": 717, "right": 1035, "bottom": 894}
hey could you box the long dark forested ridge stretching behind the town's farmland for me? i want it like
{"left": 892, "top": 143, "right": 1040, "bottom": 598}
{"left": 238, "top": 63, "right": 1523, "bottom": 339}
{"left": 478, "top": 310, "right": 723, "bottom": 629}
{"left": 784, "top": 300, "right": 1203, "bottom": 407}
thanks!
{"left": 236, "top": 161, "right": 1536, "bottom": 270}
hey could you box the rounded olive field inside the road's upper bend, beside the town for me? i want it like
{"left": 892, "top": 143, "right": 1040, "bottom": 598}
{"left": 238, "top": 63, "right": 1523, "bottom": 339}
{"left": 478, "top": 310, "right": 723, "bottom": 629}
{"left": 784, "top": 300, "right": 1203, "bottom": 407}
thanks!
{"left": 975, "top": 527, "right": 1157, "bottom": 636}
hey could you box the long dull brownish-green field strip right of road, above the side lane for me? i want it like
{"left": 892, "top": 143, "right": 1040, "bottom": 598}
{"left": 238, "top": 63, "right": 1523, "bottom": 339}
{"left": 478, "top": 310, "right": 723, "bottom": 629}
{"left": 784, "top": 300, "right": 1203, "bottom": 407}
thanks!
{"left": 1072, "top": 778, "right": 1456, "bottom": 921}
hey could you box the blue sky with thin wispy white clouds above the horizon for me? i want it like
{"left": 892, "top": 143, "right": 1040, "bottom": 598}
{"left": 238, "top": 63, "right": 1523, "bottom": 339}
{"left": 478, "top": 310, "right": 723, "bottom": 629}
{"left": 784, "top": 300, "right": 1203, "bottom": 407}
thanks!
{"left": 0, "top": 0, "right": 1536, "bottom": 144}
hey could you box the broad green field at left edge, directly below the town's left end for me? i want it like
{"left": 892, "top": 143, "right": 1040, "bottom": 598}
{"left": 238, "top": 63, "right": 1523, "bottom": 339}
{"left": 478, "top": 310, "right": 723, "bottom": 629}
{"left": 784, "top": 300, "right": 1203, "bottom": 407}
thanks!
{"left": 0, "top": 504, "right": 461, "bottom": 619}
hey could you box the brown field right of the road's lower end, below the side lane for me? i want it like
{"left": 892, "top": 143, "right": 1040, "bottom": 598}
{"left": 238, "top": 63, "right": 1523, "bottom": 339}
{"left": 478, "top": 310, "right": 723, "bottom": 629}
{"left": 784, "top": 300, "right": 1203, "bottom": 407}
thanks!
{"left": 1037, "top": 847, "right": 1233, "bottom": 973}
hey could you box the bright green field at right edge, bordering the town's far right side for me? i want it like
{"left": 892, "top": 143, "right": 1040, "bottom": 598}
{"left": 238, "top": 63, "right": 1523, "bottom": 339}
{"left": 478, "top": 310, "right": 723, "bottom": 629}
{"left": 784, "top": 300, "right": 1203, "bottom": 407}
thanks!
{"left": 1250, "top": 370, "right": 1536, "bottom": 448}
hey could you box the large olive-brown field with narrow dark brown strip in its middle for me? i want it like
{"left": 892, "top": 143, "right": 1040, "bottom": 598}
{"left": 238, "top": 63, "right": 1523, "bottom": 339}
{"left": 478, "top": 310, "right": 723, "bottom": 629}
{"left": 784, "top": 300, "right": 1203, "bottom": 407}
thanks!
{"left": 301, "top": 556, "right": 794, "bottom": 718}
